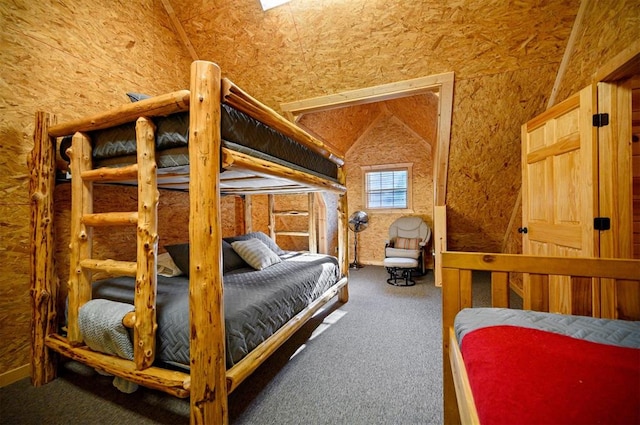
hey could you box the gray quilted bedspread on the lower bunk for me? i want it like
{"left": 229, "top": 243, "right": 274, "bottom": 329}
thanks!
{"left": 93, "top": 254, "right": 340, "bottom": 368}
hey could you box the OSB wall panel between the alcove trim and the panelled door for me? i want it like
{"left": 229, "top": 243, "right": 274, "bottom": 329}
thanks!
{"left": 447, "top": 67, "right": 554, "bottom": 252}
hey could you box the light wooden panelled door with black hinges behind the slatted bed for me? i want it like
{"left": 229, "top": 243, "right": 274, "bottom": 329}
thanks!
{"left": 522, "top": 85, "right": 599, "bottom": 314}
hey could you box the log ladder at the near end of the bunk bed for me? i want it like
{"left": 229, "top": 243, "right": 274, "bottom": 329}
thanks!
{"left": 67, "top": 117, "right": 159, "bottom": 370}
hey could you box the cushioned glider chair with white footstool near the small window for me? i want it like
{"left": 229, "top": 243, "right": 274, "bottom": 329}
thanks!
{"left": 384, "top": 216, "right": 431, "bottom": 285}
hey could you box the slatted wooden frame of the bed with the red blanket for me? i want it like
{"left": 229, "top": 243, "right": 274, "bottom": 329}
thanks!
{"left": 441, "top": 252, "right": 640, "bottom": 424}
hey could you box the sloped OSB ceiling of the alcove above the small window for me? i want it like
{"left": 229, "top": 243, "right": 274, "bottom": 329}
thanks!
{"left": 297, "top": 93, "right": 438, "bottom": 155}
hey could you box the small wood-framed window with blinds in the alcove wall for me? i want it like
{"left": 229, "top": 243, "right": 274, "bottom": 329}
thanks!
{"left": 363, "top": 164, "right": 412, "bottom": 210}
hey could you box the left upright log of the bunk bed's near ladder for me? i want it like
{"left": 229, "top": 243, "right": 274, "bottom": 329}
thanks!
{"left": 67, "top": 133, "right": 93, "bottom": 345}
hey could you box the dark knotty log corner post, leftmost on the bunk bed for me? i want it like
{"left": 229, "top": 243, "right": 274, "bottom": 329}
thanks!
{"left": 28, "top": 112, "right": 59, "bottom": 386}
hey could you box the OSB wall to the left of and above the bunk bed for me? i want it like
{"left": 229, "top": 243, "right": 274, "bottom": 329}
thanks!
{"left": 0, "top": 0, "right": 190, "bottom": 374}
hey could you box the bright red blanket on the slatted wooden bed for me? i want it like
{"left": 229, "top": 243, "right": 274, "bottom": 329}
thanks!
{"left": 461, "top": 326, "right": 640, "bottom": 424}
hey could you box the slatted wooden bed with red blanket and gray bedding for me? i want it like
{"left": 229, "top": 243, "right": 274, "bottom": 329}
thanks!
{"left": 442, "top": 252, "right": 640, "bottom": 424}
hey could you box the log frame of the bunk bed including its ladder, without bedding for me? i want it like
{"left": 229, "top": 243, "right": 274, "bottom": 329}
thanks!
{"left": 29, "top": 61, "right": 349, "bottom": 424}
